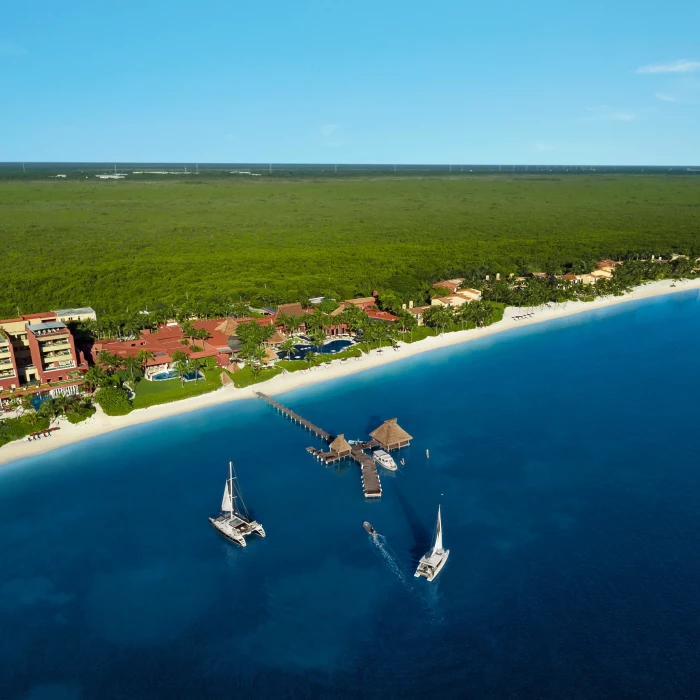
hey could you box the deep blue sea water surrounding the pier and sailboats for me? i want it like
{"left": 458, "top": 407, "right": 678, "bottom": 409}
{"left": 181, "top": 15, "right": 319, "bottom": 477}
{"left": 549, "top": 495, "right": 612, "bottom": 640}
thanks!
{"left": 0, "top": 292, "right": 700, "bottom": 700}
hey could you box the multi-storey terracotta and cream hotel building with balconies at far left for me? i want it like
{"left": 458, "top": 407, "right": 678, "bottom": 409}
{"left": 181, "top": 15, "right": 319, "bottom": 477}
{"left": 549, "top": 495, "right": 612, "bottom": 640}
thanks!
{"left": 0, "top": 311, "right": 87, "bottom": 395}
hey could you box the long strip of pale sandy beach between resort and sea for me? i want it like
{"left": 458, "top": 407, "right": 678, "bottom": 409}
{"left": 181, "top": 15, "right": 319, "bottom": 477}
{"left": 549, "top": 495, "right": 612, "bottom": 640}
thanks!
{"left": 0, "top": 279, "right": 700, "bottom": 465}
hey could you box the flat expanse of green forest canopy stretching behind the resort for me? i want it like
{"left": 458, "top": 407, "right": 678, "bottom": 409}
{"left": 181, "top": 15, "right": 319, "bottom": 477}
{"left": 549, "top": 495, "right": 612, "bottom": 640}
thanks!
{"left": 0, "top": 174, "right": 700, "bottom": 317}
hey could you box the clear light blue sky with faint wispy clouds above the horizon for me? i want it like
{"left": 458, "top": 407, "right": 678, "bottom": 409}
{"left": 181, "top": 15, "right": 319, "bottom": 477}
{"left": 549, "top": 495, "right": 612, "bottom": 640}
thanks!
{"left": 0, "top": 0, "right": 700, "bottom": 165}
